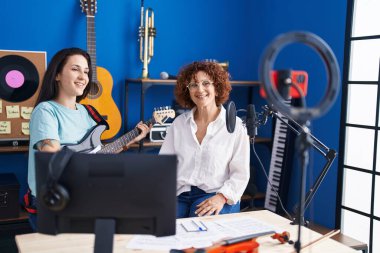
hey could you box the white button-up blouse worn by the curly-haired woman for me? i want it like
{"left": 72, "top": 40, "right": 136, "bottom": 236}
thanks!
{"left": 160, "top": 106, "right": 250, "bottom": 205}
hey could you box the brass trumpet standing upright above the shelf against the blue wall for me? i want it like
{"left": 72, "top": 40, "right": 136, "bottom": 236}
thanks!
{"left": 139, "top": 0, "right": 156, "bottom": 78}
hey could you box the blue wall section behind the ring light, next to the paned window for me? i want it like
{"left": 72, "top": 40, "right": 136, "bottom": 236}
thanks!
{"left": 252, "top": 0, "right": 346, "bottom": 227}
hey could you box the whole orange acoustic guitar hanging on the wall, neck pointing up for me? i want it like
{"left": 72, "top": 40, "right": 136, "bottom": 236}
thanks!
{"left": 80, "top": 0, "right": 121, "bottom": 140}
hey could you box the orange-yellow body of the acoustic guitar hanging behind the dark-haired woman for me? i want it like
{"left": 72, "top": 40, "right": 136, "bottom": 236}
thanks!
{"left": 81, "top": 67, "right": 121, "bottom": 140}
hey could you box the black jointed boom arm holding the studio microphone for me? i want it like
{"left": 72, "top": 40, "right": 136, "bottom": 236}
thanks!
{"left": 262, "top": 105, "right": 337, "bottom": 219}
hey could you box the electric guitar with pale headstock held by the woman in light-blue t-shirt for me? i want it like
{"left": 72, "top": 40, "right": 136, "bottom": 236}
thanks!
{"left": 66, "top": 109, "right": 175, "bottom": 154}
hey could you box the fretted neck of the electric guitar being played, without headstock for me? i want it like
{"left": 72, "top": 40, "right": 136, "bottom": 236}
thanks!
{"left": 97, "top": 118, "right": 156, "bottom": 154}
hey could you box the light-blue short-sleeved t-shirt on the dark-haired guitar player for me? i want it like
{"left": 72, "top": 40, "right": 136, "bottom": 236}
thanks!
{"left": 28, "top": 101, "right": 96, "bottom": 196}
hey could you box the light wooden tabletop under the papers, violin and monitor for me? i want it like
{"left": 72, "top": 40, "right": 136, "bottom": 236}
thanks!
{"left": 16, "top": 210, "right": 356, "bottom": 253}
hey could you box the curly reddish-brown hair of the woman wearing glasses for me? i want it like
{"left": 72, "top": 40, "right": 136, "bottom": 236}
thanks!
{"left": 174, "top": 61, "right": 232, "bottom": 108}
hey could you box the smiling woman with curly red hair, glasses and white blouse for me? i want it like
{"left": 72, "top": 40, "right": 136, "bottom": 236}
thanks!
{"left": 160, "top": 62, "right": 250, "bottom": 218}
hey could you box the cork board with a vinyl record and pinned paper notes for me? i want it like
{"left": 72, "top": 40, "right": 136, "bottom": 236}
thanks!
{"left": 0, "top": 50, "right": 46, "bottom": 145}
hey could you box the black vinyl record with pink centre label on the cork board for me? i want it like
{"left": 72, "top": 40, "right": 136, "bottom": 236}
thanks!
{"left": 0, "top": 55, "right": 39, "bottom": 102}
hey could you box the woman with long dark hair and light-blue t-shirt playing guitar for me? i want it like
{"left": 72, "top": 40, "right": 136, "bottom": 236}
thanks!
{"left": 24, "top": 48, "right": 149, "bottom": 230}
